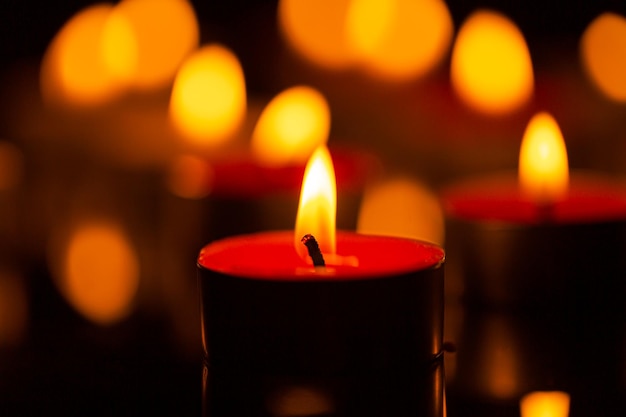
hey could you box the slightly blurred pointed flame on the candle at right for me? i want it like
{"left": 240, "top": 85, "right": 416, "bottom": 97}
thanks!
{"left": 519, "top": 113, "right": 569, "bottom": 204}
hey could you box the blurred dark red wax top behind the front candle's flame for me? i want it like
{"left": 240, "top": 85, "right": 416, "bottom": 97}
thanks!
{"left": 212, "top": 149, "right": 377, "bottom": 197}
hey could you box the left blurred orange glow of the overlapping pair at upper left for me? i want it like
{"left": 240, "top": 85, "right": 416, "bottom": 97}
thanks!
{"left": 41, "top": 4, "right": 136, "bottom": 106}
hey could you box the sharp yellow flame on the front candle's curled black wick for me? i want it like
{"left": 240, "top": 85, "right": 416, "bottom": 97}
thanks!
{"left": 294, "top": 145, "right": 337, "bottom": 259}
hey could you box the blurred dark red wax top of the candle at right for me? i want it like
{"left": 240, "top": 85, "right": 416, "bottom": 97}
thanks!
{"left": 442, "top": 173, "right": 626, "bottom": 224}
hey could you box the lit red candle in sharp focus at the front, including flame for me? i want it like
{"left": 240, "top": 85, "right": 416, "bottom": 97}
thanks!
{"left": 198, "top": 147, "right": 444, "bottom": 416}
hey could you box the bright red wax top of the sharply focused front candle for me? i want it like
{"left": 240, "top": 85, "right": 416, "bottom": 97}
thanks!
{"left": 198, "top": 231, "right": 444, "bottom": 281}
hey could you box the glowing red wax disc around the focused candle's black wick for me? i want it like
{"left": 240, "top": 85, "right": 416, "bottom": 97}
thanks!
{"left": 197, "top": 230, "right": 445, "bottom": 283}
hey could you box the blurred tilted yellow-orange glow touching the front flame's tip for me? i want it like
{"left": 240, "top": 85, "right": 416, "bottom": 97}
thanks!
{"left": 251, "top": 86, "right": 330, "bottom": 166}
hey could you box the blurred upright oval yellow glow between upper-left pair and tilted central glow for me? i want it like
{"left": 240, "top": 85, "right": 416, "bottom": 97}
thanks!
{"left": 170, "top": 44, "right": 246, "bottom": 147}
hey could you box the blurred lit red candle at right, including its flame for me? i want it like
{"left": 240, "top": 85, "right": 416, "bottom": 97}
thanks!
{"left": 442, "top": 113, "right": 626, "bottom": 415}
